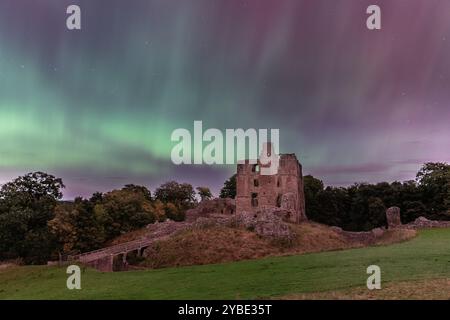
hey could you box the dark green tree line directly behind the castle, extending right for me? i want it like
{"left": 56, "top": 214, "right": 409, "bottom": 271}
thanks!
{"left": 220, "top": 163, "right": 450, "bottom": 231}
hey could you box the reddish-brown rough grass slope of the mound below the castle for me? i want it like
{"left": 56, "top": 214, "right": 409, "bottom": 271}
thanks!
{"left": 139, "top": 223, "right": 416, "bottom": 268}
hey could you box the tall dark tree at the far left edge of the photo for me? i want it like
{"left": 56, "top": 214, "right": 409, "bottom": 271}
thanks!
{"left": 0, "top": 172, "right": 64, "bottom": 263}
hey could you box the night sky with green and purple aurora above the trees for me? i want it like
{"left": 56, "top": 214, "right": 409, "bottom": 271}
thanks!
{"left": 0, "top": 0, "right": 450, "bottom": 198}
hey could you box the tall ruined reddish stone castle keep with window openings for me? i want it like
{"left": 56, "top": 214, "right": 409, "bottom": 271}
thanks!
{"left": 236, "top": 154, "right": 307, "bottom": 223}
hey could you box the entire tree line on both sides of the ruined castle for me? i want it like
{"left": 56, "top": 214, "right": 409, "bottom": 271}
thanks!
{"left": 0, "top": 163, "right": 450, "bottom": 263}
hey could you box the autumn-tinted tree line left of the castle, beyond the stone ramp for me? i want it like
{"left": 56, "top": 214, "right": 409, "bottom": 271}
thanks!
{"left": 0, "top": 172, "right": 211, "bottom": 264}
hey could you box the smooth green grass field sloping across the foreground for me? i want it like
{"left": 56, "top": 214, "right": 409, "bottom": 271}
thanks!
{"left": 0, "top": 229, "right": 450, "bottom": 299}
